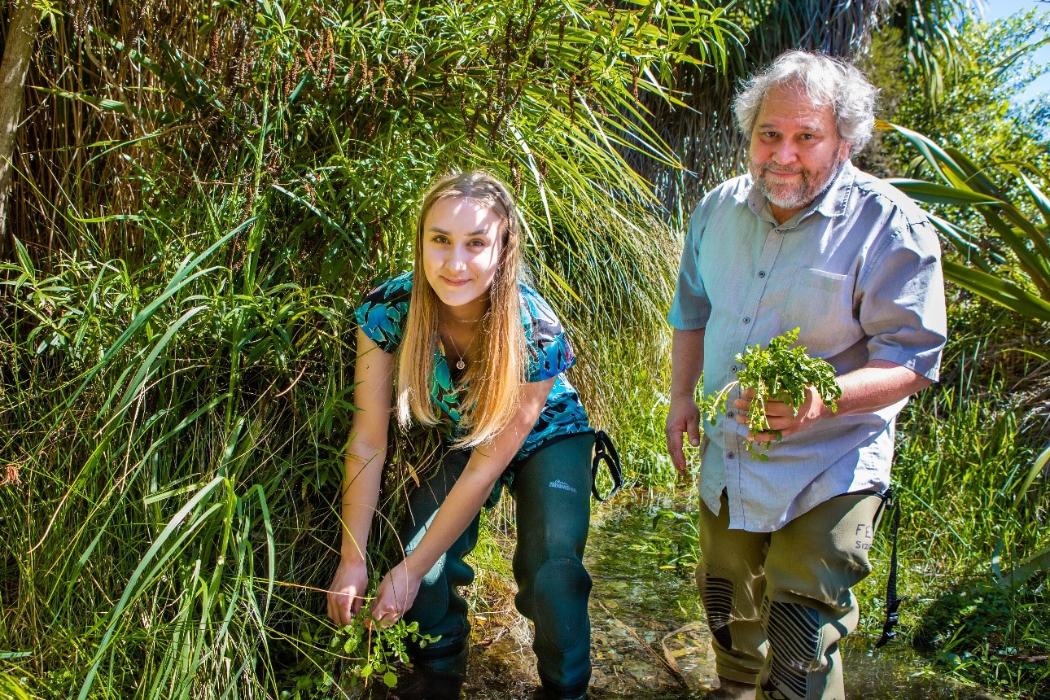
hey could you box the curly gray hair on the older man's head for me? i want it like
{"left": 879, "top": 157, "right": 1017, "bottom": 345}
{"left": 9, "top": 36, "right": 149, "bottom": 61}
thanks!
{"left": 733, "top": 51, "right": 878, "bottom": 152}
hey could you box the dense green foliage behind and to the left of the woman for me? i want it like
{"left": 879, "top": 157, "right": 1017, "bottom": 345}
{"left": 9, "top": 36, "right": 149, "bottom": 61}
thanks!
{"left": 0, "top": 1, "right": 733, "bottom": 698}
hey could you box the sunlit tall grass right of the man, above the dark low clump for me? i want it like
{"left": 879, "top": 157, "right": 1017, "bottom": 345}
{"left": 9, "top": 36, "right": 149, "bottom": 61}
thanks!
{"left": 896, "top": 290, "right": 1050, "bottom": 568}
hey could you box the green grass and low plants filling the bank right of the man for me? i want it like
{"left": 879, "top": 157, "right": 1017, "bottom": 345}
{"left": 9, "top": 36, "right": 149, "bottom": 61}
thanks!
{"left": 864, "top": 296, "right": 1050, "bottom": 698}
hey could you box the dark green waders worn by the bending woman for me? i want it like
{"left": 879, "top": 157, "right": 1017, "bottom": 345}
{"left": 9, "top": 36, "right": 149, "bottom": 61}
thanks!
{"left": 401, "top": 432, "right": 621, "bottom": 697}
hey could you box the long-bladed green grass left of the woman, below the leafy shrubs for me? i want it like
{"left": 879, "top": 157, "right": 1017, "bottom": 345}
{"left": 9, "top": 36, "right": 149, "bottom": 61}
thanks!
{"left": 0, "top": 211, "right": 352, "bottom": 697}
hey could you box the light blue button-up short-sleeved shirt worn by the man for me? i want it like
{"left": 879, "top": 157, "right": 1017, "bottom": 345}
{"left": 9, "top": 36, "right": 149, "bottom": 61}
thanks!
{"left": 668, "top": 162, "right": 946, "bottom": 532}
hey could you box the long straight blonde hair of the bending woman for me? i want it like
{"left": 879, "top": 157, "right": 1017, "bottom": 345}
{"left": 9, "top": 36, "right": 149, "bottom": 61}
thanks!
{"left": 397, "top": 171, "right": 528, "bottom": 447}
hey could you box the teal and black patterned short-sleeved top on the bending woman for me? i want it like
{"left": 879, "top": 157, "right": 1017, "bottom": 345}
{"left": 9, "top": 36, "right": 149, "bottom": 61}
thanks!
{"left": 354, "top": 272, "right": 591, "bottom": 461}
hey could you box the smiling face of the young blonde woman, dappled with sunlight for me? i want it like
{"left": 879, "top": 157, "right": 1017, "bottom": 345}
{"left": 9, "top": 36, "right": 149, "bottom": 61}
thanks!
{"left": 422, "top": 197, "right": 503, "bottom": 320}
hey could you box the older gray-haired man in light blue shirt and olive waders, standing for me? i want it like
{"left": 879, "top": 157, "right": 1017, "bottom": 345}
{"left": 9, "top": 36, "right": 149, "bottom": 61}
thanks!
{"left": 667, "top": 51, "right": 945, "bottom": 700}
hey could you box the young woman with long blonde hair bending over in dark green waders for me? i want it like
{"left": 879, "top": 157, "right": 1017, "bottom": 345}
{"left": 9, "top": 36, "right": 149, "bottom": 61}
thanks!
{"left": 328, "top": 172, "right": 594, "bottom": 698}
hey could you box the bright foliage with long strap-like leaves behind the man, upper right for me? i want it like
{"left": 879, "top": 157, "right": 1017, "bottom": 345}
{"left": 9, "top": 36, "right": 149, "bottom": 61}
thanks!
{"left": 872, "top": 10, "right": 1050, "bottom": 329}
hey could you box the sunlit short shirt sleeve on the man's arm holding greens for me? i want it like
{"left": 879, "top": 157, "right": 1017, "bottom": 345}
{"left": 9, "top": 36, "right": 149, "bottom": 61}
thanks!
{"left": 858, "top": 222, "right": 947, "bottom": 381}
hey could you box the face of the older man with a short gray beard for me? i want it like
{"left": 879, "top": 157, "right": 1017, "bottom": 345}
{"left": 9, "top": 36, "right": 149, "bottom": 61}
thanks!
{"left": 748, "top": 85, "right": 849, "bottom": 222}
